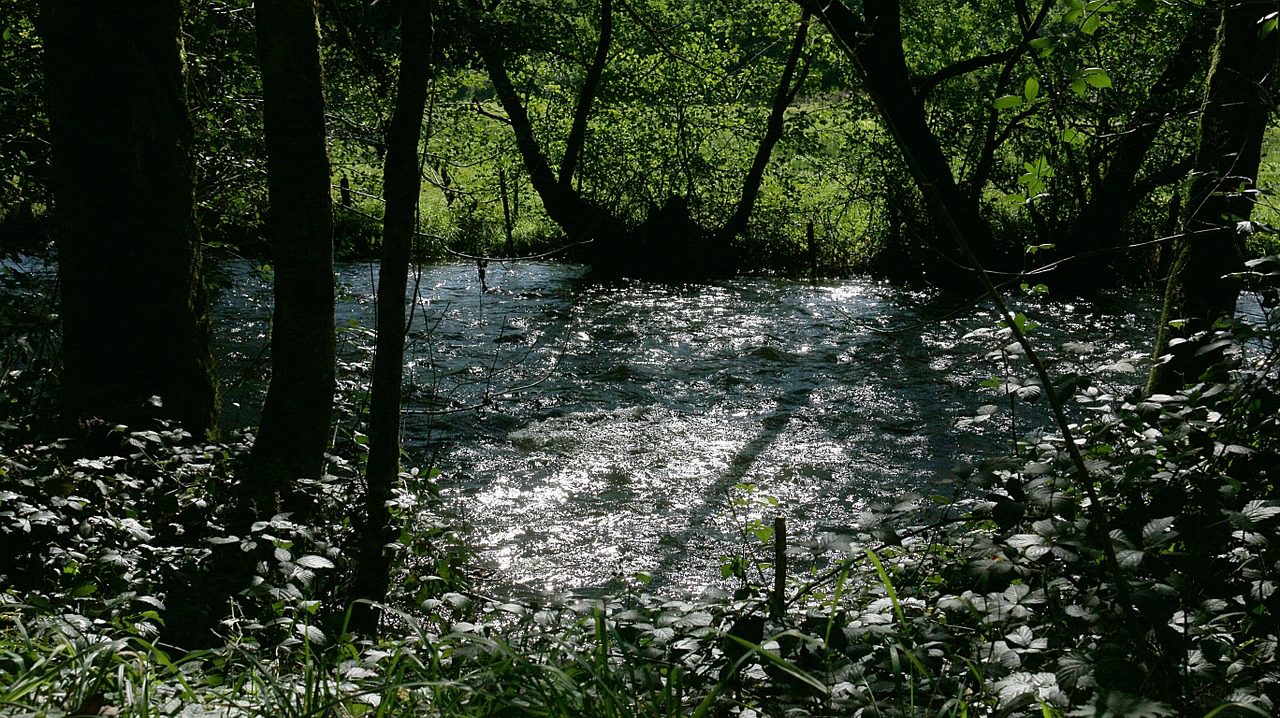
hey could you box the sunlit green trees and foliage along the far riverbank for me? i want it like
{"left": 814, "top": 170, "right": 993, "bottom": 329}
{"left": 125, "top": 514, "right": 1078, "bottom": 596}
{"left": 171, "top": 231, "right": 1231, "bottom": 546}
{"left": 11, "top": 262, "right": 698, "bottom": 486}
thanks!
{"left": 0, "top": 0, "right": 1270, "bottom": 284}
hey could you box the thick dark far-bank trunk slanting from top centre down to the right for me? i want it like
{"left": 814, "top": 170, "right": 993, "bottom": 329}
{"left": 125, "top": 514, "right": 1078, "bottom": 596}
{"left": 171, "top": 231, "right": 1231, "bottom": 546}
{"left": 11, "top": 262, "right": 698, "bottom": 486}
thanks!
{"left": 796, "top": 0, "right": 997, "bottom": 278}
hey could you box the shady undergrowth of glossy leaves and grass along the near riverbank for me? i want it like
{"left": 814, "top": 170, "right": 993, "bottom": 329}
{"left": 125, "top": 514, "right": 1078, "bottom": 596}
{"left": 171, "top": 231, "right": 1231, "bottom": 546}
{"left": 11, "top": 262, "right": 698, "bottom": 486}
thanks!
{"left": 0, "top": 258, "right": 1280, "bottom": 717}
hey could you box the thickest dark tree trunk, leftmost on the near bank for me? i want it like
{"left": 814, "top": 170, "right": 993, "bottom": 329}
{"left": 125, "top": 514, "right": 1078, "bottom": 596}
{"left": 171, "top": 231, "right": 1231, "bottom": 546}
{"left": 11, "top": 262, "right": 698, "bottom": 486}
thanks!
{"left": 40, "top": 0, "right": 218, "bottom": 436}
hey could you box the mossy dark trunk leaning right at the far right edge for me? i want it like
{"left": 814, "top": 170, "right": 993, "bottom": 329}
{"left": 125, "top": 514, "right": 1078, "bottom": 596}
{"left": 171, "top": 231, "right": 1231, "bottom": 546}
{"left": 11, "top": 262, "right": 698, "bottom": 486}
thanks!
{"left": 1147, "top": 0, "right": 1277, "bottom": 393}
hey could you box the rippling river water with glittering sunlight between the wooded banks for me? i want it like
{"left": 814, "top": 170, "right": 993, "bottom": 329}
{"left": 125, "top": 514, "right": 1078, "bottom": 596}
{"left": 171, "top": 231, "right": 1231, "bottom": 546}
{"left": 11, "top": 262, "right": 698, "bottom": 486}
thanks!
{"left": 215, "top": 262, "right": 1156, "bottom": 591}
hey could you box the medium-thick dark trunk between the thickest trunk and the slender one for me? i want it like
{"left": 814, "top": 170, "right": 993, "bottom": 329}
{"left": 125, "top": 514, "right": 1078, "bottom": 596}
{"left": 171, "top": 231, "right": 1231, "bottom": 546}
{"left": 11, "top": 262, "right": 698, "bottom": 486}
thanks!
{"left": 248, "top": 0, "right": 335, "bottom": 515}
